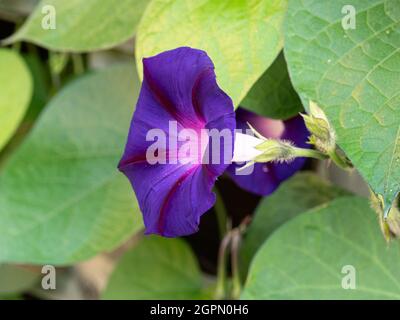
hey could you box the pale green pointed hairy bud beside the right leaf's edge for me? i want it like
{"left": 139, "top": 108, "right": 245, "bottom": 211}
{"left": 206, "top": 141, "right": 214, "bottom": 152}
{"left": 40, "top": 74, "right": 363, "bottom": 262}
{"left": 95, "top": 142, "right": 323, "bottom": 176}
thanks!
{"left": 301, "top": 101, "right": 336, "bottom": 154}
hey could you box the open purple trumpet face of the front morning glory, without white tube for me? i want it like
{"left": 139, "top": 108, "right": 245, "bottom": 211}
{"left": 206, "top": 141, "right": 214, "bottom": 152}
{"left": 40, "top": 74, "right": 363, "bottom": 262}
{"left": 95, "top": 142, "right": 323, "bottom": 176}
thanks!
{"left": 118, "top": 47, "right": 236, "bottom": 237}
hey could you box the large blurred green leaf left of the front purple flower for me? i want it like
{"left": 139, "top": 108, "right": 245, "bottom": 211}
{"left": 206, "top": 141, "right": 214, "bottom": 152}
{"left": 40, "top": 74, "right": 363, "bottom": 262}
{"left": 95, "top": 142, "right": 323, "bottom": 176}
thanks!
{"left": 0, "top": 64, "right": 142, "bottom": 264}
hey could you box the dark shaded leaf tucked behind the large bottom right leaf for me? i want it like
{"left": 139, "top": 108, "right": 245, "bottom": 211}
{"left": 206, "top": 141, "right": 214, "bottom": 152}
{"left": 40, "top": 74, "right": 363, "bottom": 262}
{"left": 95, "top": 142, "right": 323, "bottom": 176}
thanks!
{"left": 240, "top": 172, "right": 350, "bottom": 275}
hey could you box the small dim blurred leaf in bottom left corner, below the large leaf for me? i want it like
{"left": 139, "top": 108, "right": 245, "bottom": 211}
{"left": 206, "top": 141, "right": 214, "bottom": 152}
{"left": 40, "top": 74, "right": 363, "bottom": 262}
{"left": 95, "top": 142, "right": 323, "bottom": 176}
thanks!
{"left": 0, "top": 265, "right": 40, "bottom": 296}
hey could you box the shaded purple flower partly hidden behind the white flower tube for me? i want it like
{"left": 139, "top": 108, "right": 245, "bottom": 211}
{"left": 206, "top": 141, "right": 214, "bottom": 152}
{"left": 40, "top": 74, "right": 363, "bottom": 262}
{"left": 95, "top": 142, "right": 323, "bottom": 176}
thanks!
{"left": 227, "top": 108, "right": 309, "bottom": 196}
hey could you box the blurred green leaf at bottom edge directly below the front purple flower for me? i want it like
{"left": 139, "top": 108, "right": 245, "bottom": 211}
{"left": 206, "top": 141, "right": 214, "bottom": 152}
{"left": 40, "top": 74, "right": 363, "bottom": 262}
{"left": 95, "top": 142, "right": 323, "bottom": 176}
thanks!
{"left": 103, "top": 236, "right": 206, "bottom": 300}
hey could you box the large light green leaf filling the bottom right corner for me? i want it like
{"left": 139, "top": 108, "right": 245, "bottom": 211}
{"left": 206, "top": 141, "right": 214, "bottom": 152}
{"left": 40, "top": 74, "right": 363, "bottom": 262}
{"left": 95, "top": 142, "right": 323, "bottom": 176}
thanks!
{"left": 242, "top": 197, "right": 400, "bottom": 299}
